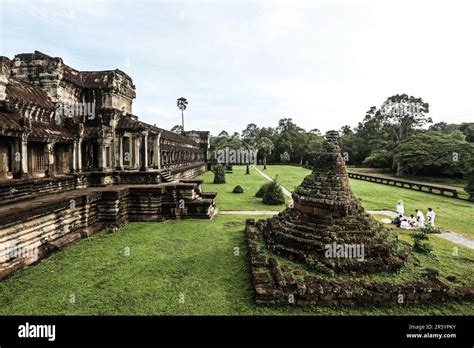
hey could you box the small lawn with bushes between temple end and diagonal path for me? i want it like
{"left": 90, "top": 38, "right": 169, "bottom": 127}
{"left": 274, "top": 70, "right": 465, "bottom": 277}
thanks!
{"left": 199, "top": 166, "right": 288, "bottom": 211}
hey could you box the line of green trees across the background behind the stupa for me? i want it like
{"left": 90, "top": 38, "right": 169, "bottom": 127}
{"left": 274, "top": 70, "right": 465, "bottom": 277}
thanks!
{"left": 174, "top": 94, "right": 474, "bottom": 188}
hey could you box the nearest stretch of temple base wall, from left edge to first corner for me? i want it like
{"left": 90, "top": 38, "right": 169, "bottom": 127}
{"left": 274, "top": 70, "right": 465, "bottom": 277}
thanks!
{"left": 0, "top": 193, "right": 101, "bottom": 279}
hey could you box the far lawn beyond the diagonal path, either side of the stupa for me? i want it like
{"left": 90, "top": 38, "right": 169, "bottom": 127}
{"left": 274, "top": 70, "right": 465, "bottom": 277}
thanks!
{"left": 258, "top": 166, "right": 474, "bottom": 239}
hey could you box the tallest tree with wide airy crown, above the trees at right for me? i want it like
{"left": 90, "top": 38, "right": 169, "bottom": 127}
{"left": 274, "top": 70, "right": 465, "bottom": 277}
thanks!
{"left": 380, "top": 94, "right": 432, "bottom": 175}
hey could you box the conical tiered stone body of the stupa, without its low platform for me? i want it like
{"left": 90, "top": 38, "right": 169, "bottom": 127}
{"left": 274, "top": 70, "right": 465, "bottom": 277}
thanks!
{"left": 250, "top": 131, "right": 408, "bottom": 274}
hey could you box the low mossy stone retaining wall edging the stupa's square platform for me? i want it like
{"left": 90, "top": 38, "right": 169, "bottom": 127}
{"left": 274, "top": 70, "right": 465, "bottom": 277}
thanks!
{"left": 245, "top": 220, "right": 474, "bottom": 307}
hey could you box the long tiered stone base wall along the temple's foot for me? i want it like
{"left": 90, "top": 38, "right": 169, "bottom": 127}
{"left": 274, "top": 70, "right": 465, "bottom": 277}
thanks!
{"left": 0, "top": 180, "right": 216, "bottom": 279}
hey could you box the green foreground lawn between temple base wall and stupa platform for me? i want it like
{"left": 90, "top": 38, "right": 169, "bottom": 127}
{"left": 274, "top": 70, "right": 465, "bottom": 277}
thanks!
{"left": 0, "top": 215, "right": 474, "bottom": 315}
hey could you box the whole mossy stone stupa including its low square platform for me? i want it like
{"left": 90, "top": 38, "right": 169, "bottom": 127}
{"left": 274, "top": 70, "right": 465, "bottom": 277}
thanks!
{"left": 245, "top": 131, "right": 472, "bottom": 306}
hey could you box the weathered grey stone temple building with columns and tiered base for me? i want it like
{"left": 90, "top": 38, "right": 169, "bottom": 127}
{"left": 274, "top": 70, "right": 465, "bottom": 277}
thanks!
{"left": 0, "top": 51, "right": 215, "bottom": 278}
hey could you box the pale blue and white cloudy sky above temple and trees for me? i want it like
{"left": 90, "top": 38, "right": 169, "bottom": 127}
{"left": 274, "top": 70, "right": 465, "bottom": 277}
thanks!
{"left": 0, "top": 0, "right": 474, "bottom": 135}
